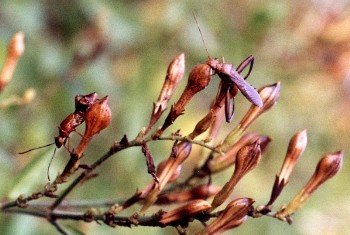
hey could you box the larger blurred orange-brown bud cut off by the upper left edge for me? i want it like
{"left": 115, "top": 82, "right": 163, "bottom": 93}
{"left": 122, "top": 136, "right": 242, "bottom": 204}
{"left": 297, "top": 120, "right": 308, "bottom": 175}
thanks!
{"left": 0, "top": 32, "right": 25, "bottom": 91}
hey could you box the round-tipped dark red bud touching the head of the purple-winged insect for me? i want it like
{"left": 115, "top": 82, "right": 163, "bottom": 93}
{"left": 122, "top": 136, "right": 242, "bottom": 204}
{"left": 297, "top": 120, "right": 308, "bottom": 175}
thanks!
{"left": 155, "top": 64, "right": 212, "bottom": 138}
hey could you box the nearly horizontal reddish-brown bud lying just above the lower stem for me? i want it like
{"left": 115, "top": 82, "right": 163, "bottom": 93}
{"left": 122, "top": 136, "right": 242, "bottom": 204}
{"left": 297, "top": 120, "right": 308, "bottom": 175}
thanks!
{"left": 156, "top": 184, "right": 221, "bottom": 204}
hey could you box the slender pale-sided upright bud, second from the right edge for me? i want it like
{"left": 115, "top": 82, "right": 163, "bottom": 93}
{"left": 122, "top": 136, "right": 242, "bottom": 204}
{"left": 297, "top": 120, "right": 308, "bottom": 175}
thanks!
{"left": 266, "top": 129, "right": 307, "bottom": 206}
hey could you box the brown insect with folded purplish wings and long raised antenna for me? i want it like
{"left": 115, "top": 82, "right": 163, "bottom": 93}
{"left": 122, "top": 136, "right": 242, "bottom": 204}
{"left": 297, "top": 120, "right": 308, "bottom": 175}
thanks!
{"left": 193, "top": 14, "right": 263, "bottom": 122}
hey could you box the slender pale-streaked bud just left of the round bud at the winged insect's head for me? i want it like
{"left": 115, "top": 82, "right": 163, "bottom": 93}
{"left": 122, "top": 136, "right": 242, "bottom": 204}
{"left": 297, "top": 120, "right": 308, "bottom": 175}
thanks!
{"left": 145, "top": 53, "right": 185, "bottom": 133}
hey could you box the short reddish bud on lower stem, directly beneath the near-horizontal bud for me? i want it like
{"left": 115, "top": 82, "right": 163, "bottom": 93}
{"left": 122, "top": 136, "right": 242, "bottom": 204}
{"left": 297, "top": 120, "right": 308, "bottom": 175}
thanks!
{"left": 159, "top": 200, "right": 210, "bottom": 224}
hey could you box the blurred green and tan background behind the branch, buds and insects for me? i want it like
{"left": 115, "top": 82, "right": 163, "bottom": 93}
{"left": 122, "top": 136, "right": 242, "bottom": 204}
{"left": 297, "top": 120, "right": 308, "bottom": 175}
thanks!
{"left": 0, "top": 0, "right": 350, "bottom": 234}
